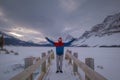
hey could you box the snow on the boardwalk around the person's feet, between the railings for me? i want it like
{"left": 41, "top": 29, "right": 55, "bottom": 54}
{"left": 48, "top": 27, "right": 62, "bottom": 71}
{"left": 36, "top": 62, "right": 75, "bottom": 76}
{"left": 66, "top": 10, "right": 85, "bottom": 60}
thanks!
{"left": 44, "top": 59, "right": 79, "bottom": 80}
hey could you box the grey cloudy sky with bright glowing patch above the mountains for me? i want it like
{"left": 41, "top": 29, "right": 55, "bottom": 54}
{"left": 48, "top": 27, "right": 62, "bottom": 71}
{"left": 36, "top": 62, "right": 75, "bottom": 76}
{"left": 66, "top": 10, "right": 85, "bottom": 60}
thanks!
{"left": 0, "top": 0, "right": 120, "bottom": 41}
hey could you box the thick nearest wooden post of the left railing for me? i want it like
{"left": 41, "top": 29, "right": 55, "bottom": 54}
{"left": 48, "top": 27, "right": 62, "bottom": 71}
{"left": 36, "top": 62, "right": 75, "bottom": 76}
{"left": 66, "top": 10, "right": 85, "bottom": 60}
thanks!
{"left": 24, "top": 57, "right": 34, "bottom": 80}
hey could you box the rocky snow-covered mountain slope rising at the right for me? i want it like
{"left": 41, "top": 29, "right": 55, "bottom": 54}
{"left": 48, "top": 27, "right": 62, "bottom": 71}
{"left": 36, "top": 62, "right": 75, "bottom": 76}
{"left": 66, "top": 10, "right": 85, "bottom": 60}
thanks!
{"left": 73, "top": 13, "right": 120, "bottom": 46}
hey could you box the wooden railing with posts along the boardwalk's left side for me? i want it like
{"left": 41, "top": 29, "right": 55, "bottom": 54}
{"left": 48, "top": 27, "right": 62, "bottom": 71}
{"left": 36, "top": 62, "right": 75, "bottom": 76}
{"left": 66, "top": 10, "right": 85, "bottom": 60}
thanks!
{"left": 10, "top": 50, "right": 54, "bottom": 80}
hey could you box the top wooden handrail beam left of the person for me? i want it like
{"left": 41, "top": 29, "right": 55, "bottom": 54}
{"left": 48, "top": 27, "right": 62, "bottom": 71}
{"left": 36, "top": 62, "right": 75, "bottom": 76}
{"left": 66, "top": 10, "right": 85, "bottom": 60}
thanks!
{"left": 10, "top": 54, "right": 51, "bottom": 80}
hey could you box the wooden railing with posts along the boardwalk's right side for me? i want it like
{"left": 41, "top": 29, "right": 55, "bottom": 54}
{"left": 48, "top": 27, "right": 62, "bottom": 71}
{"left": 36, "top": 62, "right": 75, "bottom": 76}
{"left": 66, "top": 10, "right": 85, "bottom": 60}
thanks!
{"left": 65, "top": 50, "right": 107, "bottom": 80}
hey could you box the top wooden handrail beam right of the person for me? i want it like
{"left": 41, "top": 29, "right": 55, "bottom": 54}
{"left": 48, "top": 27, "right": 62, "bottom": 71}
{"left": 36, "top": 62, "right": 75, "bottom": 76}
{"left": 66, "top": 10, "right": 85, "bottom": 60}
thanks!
{"left": 66, "top": 52, "right": 107, "bottom": 80}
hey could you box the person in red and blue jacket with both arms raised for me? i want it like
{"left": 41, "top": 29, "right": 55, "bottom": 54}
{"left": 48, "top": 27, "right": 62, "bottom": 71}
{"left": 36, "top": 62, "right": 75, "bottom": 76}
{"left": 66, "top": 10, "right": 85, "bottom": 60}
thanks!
{"left": 45, "top": 37, "right": 75, "bottom": 73}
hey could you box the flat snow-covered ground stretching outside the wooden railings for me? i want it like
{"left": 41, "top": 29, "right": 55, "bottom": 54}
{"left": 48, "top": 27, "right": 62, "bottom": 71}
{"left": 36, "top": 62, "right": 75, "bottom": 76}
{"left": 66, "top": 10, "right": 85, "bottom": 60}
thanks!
{"left": 0, "top": 46, "right": 120, "bottom": 80}
